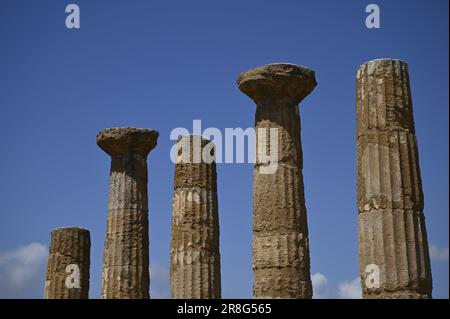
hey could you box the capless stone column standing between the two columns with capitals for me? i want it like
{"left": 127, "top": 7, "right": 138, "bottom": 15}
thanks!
{"left": 170, "top": 135, "right": 221, "bottom": 299}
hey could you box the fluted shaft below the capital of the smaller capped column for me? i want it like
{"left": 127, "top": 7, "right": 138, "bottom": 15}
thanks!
{"left": 102, "top": 154, "right": 150, "bottom": 299}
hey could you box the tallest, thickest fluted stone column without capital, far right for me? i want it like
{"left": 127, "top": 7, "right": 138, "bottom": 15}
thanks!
{"left": 356, "top": 59, "right": 432, "bottom": 298}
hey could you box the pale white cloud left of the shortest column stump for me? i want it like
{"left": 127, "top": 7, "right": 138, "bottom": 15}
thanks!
{"left": 0, "top": 243, "right": 48, "bottom": 298}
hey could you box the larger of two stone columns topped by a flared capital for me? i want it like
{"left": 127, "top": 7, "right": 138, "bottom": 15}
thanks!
{"left": 237, "top": 64, "right": 316, "bottom": 298}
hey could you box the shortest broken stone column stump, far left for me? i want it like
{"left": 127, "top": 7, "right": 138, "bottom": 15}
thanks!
{"left": 44, "top": 227, "right": 91, "bottom": 299}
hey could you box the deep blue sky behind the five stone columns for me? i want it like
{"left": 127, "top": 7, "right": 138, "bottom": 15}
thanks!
{"left": 0, "top": 0, "right": 449, "bottom": 298}
